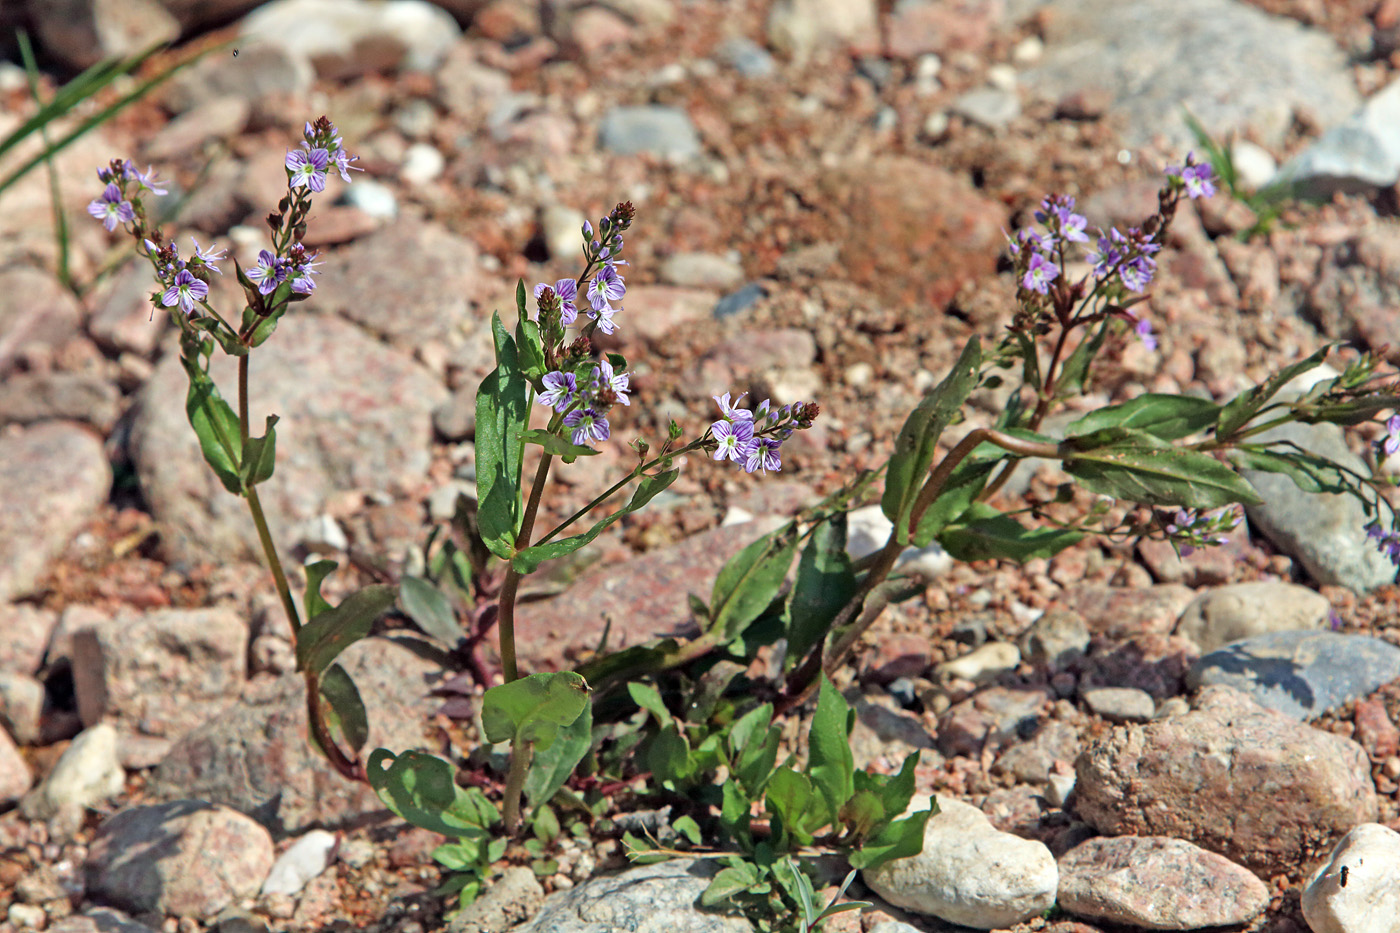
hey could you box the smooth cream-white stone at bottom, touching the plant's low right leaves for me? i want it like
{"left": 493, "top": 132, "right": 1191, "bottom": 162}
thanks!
{"left": 861, "top": 796, "right": 1060, "bottom": 930}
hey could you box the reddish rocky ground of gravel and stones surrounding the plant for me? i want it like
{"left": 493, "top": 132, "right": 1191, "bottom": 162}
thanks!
{"left": 0, "top": 0, "right": 1400, "bottom": 933}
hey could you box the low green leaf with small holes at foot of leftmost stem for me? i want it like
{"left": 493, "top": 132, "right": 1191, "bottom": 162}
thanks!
{"left": 364, "top": 748, "right": 500, "bottom": 839}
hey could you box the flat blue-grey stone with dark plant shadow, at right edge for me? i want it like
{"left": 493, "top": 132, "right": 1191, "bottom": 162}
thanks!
{"left": 1186, "top": 632, "right": 1400, "bottom": 719}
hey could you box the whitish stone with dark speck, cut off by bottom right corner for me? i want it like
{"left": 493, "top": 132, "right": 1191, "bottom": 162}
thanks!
{"left": 1302, "top": 822, "right": 1400, "bottom": 933}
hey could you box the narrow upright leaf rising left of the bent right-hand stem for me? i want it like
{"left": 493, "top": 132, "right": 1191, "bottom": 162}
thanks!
{"left": 881, "top": 338, "right": 981, "bottom": 544}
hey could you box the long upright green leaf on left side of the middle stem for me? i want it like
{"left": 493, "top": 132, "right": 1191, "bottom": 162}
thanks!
{"left": 476, "top": 314, "right": 529, "bottom": 560}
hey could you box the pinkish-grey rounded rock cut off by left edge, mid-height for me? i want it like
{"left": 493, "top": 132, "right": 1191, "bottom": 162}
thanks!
{"left": 0, "top": 423, "right": 110, "bottom": 602}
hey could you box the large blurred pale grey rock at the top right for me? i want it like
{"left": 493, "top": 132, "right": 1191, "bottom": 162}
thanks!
{"left": 1022, "top": 0, "right": 1359, "bottom": 153}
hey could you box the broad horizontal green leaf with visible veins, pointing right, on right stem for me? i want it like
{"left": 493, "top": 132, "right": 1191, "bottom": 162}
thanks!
{"left": 1064, "top": 429, "right": 1260, "bottom": 509}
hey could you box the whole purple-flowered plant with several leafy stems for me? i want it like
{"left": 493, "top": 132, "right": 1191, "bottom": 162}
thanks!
{"left": 98, "top": 118, "right": 1400, "bottom": 929}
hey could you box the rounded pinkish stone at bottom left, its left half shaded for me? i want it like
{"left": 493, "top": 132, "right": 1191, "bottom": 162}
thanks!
{"left": 87, "top": 800, "right": 273, "bottom": 919}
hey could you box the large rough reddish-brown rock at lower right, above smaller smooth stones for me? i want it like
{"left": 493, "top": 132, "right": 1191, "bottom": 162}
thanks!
{"left": 1074, "top": 686, "right": 1376, "bottom": 877}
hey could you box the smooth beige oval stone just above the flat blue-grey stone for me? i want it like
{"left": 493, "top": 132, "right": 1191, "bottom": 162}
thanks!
{"left": 1176, "top": 580, "right": 1331, "bottom": 653}
